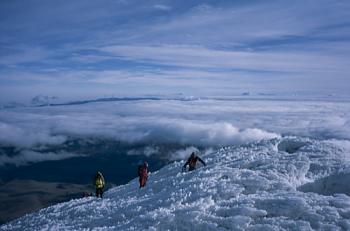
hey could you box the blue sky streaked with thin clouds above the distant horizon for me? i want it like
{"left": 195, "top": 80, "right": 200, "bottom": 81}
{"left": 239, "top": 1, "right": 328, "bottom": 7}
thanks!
{"left": 0, "top": 0, "right": 350, "bottom": 102}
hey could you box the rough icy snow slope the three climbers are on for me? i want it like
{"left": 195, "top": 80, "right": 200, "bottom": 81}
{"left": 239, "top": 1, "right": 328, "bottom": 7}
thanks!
{"left": 1, "top": 137, "right": 350, "bottom": 230}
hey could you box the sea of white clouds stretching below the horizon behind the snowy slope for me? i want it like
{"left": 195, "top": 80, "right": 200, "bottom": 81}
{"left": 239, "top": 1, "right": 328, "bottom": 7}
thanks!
{"left": 0, "top": 99, "right": 350, "bottom": 165}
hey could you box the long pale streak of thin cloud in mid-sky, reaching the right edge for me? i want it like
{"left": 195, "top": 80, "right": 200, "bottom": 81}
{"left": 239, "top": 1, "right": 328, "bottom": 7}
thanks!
{"left": 101, "top": 45, "right": 348, "bottom": 73}
